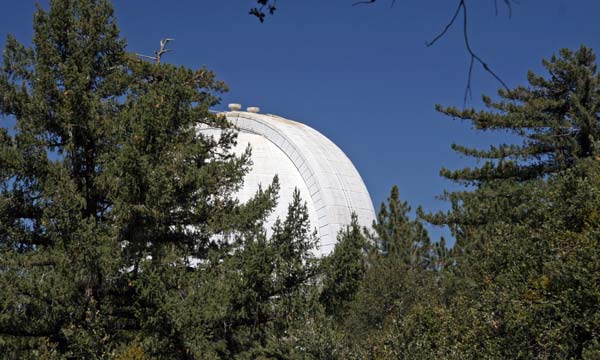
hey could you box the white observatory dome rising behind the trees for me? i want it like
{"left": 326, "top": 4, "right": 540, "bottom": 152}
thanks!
{"left": 201, "top": 104, "right": 375, "bottom": 255}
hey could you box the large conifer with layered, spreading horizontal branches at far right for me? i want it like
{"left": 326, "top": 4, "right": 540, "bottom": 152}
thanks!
{"left": 426, "top": 46, "right": 600, "bottom": 278}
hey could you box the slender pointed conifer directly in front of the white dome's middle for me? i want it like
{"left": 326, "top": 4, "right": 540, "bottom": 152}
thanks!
{"left": 233, "top": 189, "right": 318, "bottom": 359}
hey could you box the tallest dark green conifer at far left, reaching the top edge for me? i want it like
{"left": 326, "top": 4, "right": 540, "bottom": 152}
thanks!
{"left": 0, "top": 1, "right": 132, "bottom": 358}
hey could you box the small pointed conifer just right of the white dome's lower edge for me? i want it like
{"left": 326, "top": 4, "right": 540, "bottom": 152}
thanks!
{"left": 340, "top": 186, "right": 448, "bottom": 358}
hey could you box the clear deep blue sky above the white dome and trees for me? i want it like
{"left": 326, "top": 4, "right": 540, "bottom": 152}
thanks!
{"left": 0, "top": 0, "right": 600, "bottom": 243}
